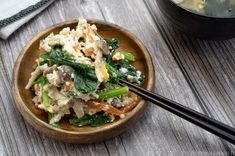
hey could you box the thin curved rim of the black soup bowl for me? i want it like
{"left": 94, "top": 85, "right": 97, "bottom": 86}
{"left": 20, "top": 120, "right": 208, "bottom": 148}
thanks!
{"left": 168, "top": 0, "right": 235, "bottom": 20}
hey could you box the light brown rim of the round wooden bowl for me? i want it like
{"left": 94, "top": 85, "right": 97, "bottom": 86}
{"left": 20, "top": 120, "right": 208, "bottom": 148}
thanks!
{"left": 12, "top": 19, "right": 155, "bottom": 135}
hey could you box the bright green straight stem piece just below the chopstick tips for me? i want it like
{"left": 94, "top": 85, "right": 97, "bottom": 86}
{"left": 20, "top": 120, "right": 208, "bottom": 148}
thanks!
{"left": 98, "top": 86, "right": 129, "bottom": 100}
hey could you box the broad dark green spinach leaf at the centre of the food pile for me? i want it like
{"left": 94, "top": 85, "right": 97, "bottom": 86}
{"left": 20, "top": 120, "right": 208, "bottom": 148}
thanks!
{"left": 74, "top": 71, "right": 97, "bottom": 94}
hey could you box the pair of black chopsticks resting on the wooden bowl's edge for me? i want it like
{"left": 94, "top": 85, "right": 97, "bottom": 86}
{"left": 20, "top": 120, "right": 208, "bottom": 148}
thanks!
{"left": 119, "top": 80, "right": 235, "bottom": 144}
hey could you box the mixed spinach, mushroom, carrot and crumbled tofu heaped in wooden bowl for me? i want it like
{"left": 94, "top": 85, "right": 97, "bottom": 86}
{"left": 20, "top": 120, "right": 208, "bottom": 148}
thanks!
{"left": 25, "top": 18, "right": 144, "bottom": 127}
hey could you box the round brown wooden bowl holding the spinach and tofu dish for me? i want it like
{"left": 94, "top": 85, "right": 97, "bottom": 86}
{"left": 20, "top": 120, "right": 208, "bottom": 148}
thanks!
{"left": 12, "top": 20, "right": 155, "bottom": 143}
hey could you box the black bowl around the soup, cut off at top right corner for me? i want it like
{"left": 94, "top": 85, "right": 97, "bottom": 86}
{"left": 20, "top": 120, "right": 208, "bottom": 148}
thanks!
{"left": 157, "top": 0, "right": 235, "bottom": 39}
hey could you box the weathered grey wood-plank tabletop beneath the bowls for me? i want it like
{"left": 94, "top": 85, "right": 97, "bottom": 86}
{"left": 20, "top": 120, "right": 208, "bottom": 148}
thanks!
{"left": 0, "top": 0, "right": 235, "bottom": 156}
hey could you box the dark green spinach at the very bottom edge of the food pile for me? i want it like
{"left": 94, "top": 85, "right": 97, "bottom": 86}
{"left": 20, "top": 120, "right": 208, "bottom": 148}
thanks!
{"left": 69, "top": 112, "right": 112, "bottom": 127}
